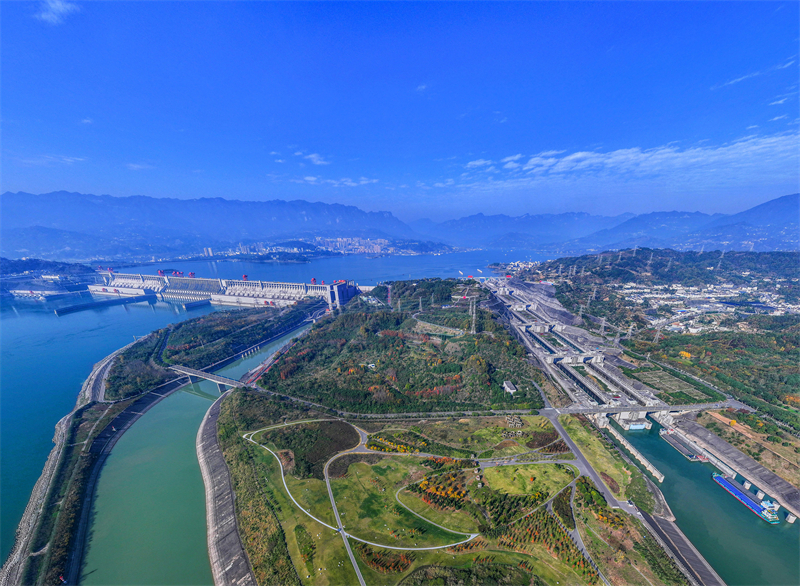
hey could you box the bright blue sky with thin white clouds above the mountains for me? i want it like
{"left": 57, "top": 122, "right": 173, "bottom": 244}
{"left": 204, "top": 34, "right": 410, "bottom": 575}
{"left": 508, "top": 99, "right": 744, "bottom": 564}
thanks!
{"left": 0, "top": 0, "right": 800, "bottom": 220}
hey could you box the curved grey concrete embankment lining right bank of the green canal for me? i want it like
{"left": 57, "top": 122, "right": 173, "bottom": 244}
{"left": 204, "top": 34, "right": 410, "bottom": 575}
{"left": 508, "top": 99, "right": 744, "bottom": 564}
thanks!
{"left": 196, "top": 391, "right": 256, "bottom": 586}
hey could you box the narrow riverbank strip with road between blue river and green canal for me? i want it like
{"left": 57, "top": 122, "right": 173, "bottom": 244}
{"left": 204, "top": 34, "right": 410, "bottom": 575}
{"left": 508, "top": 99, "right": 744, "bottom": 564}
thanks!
{"left": 0, "top": 304, "right": 316, "bottom": 585}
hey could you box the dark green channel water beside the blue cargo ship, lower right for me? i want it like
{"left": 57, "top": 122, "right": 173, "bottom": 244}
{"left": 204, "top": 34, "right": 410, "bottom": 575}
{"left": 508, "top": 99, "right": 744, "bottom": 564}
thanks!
{"left": 622, "top": 424, "right": 800, "bottom": 586}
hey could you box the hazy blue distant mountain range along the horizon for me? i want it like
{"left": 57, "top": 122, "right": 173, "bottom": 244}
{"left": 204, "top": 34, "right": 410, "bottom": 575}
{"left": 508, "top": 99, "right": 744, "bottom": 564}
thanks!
{"left": 0, "top": 191, "right": 800, "bottom": 260}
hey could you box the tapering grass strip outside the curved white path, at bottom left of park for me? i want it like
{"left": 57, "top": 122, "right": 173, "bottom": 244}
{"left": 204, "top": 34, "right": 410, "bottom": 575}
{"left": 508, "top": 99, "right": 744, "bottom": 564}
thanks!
{"left": 255, "top": 442, "right": 358, "bottom": 586}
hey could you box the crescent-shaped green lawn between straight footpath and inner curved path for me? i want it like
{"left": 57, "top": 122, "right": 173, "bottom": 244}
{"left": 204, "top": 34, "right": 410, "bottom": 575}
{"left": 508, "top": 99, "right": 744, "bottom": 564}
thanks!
{"left": 331, "top": 457, "right": 464, "bottom": 547}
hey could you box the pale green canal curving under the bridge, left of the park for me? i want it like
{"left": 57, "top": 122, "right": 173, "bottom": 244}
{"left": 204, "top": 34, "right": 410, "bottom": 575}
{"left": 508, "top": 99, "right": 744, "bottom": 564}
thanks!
{"left": 80, "top": 326, "right": 308, "bottom": 586}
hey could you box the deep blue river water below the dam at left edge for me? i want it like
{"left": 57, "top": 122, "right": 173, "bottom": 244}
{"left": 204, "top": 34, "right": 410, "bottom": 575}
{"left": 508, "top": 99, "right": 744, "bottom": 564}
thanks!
{"left": 0, "top": 302, "right": 213, "bottom": 560}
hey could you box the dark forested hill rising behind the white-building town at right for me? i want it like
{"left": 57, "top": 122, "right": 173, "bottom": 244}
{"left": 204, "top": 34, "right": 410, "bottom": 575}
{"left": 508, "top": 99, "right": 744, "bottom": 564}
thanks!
{"left": 524, "top": 248, "right": 800, "bottom": 286}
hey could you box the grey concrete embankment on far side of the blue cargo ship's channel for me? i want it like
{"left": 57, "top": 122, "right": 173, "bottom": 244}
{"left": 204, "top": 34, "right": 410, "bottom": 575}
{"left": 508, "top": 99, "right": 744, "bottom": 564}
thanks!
{"left": 675, "top": 419, "right": 800, "bottom": 517}
